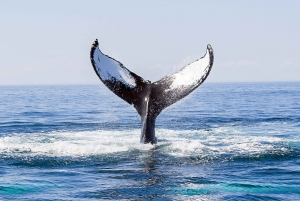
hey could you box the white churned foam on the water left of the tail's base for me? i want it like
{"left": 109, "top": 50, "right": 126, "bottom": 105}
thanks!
{"left": 0, "top": 130, "right": 153, "bottom": 156}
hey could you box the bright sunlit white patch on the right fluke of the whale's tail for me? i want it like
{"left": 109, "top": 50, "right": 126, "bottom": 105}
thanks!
{"left": 166, "top": 49, "right": 210, "bottom": 91}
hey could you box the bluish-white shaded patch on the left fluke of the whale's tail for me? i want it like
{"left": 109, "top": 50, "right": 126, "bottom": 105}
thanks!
{"left": 94, "top": 48, "right": 136, "bottom": 88}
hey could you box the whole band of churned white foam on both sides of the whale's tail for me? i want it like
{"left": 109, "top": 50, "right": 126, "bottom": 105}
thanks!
{"left": 0, "top": 127, "right": 300, "bottom": 158}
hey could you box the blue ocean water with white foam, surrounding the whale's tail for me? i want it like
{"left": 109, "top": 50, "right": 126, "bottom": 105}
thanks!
{"left": 0, "top": 83, "right": 300, "bottom": 200}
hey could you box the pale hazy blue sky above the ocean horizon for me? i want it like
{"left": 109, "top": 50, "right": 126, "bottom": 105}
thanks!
{"left": 0, "top": 0, "right": 300, "bottom": 85}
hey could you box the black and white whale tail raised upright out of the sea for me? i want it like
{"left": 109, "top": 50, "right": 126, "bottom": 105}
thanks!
{"left": 90, "top": 39, "right": 214, "bottom": 144}
